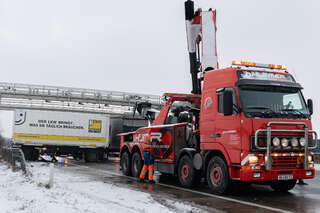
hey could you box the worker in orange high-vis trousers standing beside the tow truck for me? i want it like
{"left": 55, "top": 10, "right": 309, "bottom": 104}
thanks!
{"left": 140, "top": 138, "right": 154, "bottom": 183}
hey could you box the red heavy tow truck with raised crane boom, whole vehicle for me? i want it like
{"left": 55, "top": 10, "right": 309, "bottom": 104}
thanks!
{"left": 120, "top": 0, "right": 317, "bottom": 194}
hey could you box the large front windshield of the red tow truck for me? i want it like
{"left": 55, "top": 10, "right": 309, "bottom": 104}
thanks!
{"left": 239, "top": 85, "right": 309, "bottom": 118}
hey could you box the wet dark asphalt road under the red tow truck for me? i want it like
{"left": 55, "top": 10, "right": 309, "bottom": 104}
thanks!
{"left": 53, "top": 158, "right": 320, "bottom": 213}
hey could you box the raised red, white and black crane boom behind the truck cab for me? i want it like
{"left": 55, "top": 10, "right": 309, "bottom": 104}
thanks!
{"left": 184, "top": 0, "right": 218, "bottom": 94}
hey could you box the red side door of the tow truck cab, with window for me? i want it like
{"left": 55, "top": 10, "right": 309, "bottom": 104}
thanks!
{"left": 215, "top": 87, "right": 241, "bottom": 163}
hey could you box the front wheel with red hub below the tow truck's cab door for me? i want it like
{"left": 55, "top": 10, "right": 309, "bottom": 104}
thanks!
{"left": 207, "top": 156, "right": 231, "bottom": 194}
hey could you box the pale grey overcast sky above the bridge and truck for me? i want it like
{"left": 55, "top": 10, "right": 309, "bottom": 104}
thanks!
{"left": 0, "top": 0, "right": 320, "bottom": 134}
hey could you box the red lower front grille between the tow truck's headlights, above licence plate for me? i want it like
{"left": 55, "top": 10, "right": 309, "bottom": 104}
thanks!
{"left": 272, "top": 156, "right": 303, "bottom": 169}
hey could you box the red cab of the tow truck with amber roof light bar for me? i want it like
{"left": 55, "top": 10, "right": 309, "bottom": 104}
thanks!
{"left": 200, "top": 61, "right": 317, "bottom": 191}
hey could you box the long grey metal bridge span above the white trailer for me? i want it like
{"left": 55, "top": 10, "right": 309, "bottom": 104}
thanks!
{"left": 0, "top": 82, "right": 163, "bottom": 114}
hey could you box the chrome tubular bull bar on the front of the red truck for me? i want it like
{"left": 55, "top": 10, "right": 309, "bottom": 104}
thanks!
{"left": 254, "top": 121, "right": 318, "bottom": 170}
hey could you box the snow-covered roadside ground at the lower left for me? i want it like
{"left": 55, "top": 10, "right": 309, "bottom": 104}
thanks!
{"left": 0, "top": 162, "right": 205, "bottom": 213}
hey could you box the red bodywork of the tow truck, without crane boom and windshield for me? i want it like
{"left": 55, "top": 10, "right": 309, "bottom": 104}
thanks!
{"left": 121, "top": 67, "right": 315, "bottom": 193}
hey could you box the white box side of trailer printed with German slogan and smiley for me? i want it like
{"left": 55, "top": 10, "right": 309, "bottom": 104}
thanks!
{"left": 13, "top": 110, "right": 110, "bottom": 147}
